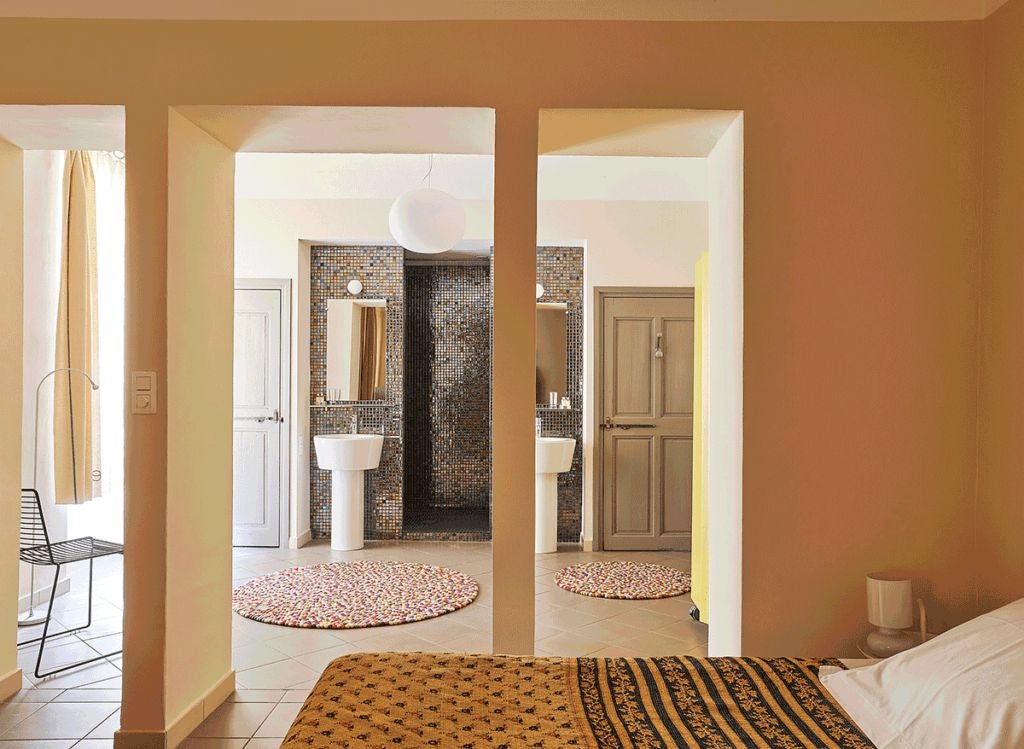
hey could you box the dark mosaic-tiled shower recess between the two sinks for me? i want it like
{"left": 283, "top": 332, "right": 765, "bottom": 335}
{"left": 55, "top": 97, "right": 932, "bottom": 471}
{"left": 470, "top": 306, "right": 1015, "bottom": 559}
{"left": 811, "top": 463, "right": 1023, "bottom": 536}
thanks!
{"left": 403, "top": 261, "right": 493, "bottom": 540}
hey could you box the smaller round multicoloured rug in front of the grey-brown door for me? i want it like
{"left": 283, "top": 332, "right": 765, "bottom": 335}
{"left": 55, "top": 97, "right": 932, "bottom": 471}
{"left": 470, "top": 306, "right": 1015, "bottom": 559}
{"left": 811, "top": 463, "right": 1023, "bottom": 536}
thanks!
{"left": 555, "top": 561, "right": 690, "bottom": 598}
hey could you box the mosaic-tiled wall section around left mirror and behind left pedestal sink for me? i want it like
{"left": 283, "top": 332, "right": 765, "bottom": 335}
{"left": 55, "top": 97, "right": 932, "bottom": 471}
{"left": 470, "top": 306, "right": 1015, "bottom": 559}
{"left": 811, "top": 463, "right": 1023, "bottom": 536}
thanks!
{"left": 309, "top": 246, "right": 406, "bottom": 539}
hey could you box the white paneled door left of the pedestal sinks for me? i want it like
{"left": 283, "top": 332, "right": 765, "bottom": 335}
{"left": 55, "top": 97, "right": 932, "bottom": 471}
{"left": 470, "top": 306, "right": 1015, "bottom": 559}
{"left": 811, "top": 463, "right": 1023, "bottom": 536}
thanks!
{"left": 232, "top": 289, "right": 285, "bottom": 546}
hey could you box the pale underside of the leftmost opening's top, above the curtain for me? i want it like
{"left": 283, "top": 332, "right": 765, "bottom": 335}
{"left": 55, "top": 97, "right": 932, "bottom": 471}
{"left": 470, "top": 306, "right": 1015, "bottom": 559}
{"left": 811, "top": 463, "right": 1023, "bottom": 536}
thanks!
{"left": 0, "top": 105, "right": 125, "bottom": 151}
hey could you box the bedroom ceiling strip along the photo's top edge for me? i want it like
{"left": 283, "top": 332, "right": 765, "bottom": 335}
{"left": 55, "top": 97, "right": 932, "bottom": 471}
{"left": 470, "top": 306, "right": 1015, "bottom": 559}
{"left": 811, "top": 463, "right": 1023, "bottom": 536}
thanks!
{"left": 0, "top": 0, "right": 1007, "bottom": 20}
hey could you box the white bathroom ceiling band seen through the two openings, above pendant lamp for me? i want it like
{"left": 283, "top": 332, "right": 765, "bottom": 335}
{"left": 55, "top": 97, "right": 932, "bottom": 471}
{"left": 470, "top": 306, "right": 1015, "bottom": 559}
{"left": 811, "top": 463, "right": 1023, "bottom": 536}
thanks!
{"left": 234, "top": 154, "right": 708, "bottom": 202}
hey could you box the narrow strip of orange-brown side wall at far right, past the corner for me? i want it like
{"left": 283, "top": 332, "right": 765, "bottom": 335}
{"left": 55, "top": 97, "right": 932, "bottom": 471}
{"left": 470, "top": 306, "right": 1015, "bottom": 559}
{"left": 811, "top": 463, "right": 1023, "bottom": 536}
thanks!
{"left": 977, "top": 0, "right": 1024, "bottom": 610}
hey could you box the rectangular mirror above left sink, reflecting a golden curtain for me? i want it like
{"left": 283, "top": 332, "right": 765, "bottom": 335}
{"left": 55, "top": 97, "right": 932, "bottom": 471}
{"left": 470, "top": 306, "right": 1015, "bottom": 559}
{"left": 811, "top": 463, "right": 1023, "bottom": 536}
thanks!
{"left": 327, "top": 299, "right": 387, "bottom": 401}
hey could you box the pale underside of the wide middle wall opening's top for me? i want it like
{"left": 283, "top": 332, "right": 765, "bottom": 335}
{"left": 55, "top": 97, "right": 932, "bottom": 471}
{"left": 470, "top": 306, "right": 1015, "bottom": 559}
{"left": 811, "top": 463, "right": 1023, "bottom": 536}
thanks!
{"left": 177, "top": 107, "right": 495, "bottom": 154}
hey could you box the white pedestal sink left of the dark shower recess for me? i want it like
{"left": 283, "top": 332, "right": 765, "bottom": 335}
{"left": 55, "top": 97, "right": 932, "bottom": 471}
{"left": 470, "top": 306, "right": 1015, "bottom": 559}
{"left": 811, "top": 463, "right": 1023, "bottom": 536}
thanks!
{"left": 313, "top": 434, "right": 384, "bottom": 551}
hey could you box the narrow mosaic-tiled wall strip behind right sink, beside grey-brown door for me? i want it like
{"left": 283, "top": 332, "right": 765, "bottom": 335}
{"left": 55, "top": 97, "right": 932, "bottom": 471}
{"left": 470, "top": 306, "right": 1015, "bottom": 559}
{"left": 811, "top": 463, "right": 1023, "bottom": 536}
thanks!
{"left": 537, "top": 247, "right": 583, "bottom": 543}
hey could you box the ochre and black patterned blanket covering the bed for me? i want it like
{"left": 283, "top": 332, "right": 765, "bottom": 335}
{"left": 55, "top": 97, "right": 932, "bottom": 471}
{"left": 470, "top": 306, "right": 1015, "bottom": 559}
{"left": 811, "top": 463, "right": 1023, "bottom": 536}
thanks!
{"left": 283, "top": 653, "right": 871, "bottom": 749}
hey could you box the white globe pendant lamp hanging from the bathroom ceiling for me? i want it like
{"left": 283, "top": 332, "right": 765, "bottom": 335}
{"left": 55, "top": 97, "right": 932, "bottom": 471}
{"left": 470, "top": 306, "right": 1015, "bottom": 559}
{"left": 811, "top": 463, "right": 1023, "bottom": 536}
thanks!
{"left": 388, "top": 188, "right": 466, "bottom": 254}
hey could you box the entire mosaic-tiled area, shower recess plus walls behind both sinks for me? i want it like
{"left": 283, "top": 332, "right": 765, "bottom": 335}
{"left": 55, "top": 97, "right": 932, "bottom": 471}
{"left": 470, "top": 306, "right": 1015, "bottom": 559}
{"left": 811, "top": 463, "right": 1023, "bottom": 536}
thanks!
{"left": 308, "top": 245, "right": 584, "bottom": 542}
